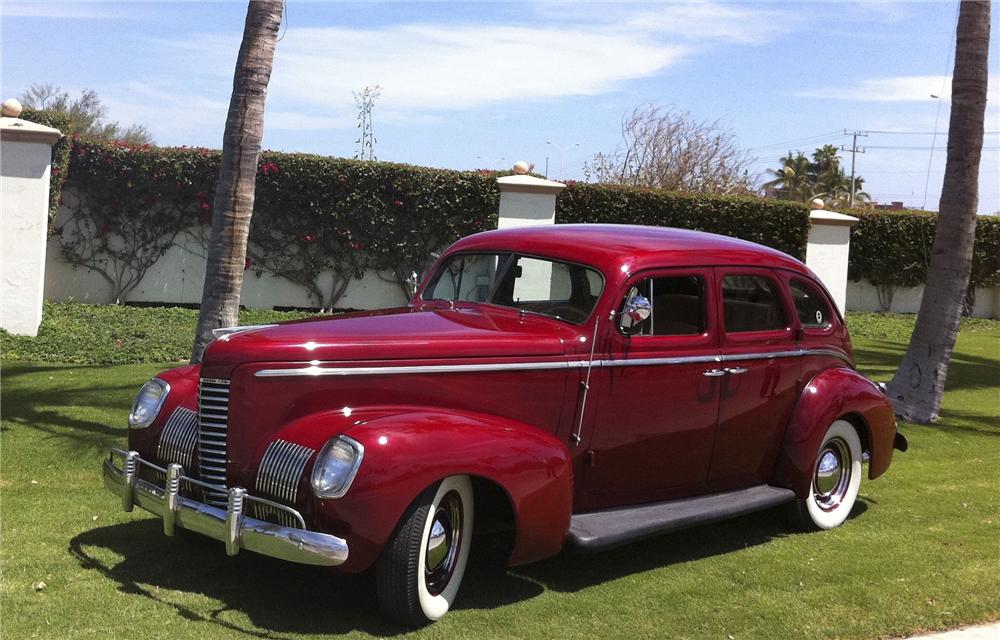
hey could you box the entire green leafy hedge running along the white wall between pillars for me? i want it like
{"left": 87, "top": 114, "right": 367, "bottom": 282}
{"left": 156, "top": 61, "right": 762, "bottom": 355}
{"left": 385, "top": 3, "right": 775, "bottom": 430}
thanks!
{"left": 45, "top": 139, "right": 1000, "bottom": 309}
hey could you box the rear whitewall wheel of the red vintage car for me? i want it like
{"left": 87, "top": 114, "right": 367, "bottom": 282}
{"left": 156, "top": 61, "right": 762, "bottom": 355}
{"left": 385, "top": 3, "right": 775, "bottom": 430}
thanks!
{"left": 798, "top": 420, "right": 861, "bottom": 530}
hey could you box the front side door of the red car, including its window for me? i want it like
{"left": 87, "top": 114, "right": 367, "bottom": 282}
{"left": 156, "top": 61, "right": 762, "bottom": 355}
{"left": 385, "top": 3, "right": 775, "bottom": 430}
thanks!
{"left": 582, "top": 268, "right": 720, "bottom": 507}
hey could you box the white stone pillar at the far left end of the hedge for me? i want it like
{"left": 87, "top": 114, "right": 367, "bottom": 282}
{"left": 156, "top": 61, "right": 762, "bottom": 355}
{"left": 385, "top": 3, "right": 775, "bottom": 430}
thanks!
{"left": 0, "top": 109, "right": 62, "bottom": 336}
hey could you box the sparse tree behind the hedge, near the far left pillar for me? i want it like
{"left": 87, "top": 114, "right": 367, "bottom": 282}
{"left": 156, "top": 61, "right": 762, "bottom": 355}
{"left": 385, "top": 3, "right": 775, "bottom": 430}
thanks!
{"left": 20, "top": 83, "right": 153, "bottom": 144}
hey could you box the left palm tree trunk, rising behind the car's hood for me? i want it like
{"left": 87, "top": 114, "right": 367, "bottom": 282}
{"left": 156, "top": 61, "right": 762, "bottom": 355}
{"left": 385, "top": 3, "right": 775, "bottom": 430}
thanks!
{"left": 191, "top": 0, "right": 283, "bottom": 363}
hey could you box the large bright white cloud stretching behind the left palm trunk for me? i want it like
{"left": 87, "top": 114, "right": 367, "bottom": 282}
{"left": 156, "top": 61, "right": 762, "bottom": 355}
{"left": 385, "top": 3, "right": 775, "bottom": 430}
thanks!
{"left": 159, "top": 2, "right": 789, "bottom": 120}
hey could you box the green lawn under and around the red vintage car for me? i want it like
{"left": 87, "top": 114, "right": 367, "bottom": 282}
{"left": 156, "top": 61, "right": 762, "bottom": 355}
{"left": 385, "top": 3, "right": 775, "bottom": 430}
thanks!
{"left": 0, "top": 316, "right": 1000, "bottom": 640}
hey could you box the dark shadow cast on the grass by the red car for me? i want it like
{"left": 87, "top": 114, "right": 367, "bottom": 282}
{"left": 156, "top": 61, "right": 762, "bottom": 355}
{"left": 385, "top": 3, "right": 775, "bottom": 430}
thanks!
{"left": 69, "top": 501, "right": 867, "bottom": 638}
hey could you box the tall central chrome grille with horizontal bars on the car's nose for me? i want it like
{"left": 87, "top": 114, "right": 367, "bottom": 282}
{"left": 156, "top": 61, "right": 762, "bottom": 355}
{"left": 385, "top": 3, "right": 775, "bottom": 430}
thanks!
{"left": 198, "top": 378, "right": 229, "bottom": 506}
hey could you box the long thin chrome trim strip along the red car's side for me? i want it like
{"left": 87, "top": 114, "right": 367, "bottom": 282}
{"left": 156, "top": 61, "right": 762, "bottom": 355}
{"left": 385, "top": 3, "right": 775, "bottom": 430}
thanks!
{"left": 254, "top": 349, "right": 851, "bottom": 378}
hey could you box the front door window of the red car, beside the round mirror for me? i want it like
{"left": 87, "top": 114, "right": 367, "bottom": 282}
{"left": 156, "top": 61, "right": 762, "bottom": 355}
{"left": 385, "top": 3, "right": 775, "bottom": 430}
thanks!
{"left": 626, "top": 276, "right": 707, "bottom": 336}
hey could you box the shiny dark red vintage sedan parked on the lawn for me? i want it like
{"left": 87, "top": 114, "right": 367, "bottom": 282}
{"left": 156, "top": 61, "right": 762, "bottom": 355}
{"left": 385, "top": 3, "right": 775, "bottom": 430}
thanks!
{"left": 104, "top": 225, "right": 906, "bottom": 625}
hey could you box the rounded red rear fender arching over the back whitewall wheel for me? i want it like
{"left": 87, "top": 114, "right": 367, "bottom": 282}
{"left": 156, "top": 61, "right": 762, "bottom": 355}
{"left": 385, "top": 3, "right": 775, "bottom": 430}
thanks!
{"left": 772, "top": 368, "right": 896, "bottom": 499}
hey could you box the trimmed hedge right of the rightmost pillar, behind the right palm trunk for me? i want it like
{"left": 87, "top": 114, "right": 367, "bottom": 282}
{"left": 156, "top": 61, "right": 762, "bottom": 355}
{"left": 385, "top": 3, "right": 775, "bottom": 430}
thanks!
{"left": 848, "top": 210, "right": 1000, "bottom": 287}
